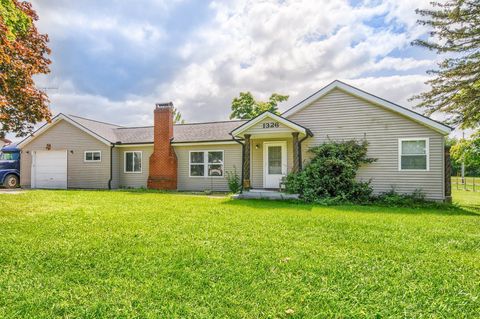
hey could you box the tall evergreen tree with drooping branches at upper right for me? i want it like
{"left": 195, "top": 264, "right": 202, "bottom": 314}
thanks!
{"left": 413, "top": 0, "right": 480, "bottom": 129}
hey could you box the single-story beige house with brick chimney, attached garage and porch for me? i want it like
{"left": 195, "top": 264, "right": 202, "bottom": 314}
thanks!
{"left": 19, "top": 81, "right": 451, "bottom": 200}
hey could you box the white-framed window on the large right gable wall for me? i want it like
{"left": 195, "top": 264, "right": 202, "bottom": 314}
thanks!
{"left": 398, "top": 137, "right": 430, "bottom": 171}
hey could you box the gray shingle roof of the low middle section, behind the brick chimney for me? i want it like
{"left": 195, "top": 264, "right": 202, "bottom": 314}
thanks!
{"left": 68, "top": 115, "right": 246, "bottom": 144}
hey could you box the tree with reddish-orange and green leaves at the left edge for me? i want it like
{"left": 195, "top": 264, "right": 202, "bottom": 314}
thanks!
{"left": 0, "top": 0, "right": 51, "bottom": 136}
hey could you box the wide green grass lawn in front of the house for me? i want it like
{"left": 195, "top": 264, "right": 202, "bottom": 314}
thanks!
{"left": 0, "top": 191, "right": 480, "bottom": 318}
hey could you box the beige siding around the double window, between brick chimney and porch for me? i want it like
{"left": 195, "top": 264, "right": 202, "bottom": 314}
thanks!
{"left": 175, "top": 144, "right": 242, "bottom": 191}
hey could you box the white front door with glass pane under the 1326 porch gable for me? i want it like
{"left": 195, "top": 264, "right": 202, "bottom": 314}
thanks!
{"left": 263, "top": 142, "right": 287, "bottom": 188}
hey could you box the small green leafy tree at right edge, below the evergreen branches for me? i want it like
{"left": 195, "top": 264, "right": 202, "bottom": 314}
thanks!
{"left": 450, "top": 131, "right": 480, "bottom": 169}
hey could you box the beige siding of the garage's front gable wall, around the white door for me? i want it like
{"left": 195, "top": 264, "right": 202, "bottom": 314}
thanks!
{"left": 20, "top": 120, "right": 110, "bottom": 188}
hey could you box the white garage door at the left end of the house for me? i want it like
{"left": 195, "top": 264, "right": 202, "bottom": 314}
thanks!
{"left": 32, "top": 151, "right": 67, "bottom": 189}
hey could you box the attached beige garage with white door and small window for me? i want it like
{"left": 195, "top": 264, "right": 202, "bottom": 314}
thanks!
{"left": 19, "top": 114, "right": 114, "bottom": 189}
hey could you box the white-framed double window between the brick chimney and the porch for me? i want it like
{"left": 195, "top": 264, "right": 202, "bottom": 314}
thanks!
{"left": 189, "top": 150, "right": 224, "bottom": 177}
